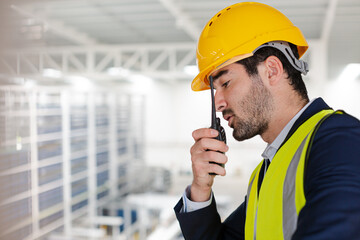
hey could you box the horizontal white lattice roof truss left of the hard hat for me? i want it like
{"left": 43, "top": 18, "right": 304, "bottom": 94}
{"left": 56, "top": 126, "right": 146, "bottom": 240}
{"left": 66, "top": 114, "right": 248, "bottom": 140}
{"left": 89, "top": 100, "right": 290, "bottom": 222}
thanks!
{"left": 0, "top": 43, "right": 196, "bottom": 77}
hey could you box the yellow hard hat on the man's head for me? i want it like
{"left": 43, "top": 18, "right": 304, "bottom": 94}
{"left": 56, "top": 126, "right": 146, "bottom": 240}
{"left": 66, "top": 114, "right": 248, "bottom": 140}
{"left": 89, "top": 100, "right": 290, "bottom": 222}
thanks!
{"left": 191, "top": 2, "right": 308, "bottom": 91}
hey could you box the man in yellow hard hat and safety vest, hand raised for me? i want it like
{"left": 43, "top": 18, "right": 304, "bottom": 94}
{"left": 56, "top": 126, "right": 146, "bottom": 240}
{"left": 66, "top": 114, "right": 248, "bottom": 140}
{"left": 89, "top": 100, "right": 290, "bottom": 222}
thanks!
{"left": 174, "top": 3, "right": 360, "bottom": 240}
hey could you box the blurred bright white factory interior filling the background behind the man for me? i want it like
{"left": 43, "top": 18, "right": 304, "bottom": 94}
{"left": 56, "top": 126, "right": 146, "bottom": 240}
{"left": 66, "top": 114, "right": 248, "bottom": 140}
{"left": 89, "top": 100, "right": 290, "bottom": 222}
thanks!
{"left": 0, "top": 0, "right": 360, "bottom": 240}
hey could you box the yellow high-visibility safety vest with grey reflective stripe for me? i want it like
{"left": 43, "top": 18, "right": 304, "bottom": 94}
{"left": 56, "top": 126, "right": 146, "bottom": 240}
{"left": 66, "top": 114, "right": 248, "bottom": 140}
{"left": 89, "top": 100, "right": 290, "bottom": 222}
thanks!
{"left": 245, "top": 110, "right": 338, "bottom": 240}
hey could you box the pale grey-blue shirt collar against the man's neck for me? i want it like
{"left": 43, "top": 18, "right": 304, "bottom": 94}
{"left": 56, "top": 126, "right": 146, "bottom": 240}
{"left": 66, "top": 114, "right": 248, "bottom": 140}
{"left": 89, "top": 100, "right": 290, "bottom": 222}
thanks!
{"left": 261, "top": 99, "right": 315, "bottom": 161}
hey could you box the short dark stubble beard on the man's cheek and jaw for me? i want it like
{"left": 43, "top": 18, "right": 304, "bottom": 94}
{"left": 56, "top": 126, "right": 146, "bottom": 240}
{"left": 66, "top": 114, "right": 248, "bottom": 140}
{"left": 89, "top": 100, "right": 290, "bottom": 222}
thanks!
{"left": 223, "top": 76, "right": 273, "bottom": 141}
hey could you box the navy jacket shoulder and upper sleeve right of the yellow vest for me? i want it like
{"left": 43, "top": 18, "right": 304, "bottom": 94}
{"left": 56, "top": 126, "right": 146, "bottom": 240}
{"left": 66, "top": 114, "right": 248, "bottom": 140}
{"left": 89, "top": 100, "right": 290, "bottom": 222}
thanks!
{"left": 292, "top": 111, "right": 360, "bottom": 239}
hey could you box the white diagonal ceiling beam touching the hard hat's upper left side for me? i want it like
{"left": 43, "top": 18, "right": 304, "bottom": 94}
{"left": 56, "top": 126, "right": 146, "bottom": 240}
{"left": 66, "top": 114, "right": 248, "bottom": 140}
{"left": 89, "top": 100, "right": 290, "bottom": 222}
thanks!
{"left": 159, "top": 0, "right": 201, "bottom": 41}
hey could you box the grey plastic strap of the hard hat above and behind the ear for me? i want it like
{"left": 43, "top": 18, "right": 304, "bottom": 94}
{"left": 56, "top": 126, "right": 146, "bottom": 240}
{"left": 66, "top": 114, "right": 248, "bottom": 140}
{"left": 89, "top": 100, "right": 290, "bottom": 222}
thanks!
{"left": 253, "top": 41, "right": 309, "bottom": 75}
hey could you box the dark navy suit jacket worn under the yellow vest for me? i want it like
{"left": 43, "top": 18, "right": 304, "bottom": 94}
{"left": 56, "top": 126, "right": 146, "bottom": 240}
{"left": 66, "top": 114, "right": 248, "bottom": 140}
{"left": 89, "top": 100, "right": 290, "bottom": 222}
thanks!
{"left": 174, "top": 98, "right": 360, "bottom": 240}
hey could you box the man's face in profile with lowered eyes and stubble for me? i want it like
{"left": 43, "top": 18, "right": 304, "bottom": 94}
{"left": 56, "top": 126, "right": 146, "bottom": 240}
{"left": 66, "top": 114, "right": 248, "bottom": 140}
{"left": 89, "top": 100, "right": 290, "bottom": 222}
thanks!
{"left": 213, "top": 63, "right": 273, "bottom": 141}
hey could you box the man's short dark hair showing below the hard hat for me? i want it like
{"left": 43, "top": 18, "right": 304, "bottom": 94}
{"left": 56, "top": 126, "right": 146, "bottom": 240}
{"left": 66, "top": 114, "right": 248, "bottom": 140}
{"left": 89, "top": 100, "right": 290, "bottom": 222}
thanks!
{"left": 237, "top": 43, "right": 309, "bottom": 101}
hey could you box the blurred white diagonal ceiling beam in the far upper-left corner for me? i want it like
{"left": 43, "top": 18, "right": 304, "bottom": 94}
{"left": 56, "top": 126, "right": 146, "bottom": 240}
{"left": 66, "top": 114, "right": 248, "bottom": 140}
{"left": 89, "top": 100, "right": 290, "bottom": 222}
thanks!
{"left": 11, "top": 5, "right": 97, "bottom": 45}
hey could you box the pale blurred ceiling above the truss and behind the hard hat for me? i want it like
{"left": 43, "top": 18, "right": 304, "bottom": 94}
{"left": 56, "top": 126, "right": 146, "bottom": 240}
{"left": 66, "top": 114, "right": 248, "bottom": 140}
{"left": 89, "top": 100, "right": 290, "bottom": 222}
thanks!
{"left": 0, "top": 0, "right": 360, "bottom": 79}
